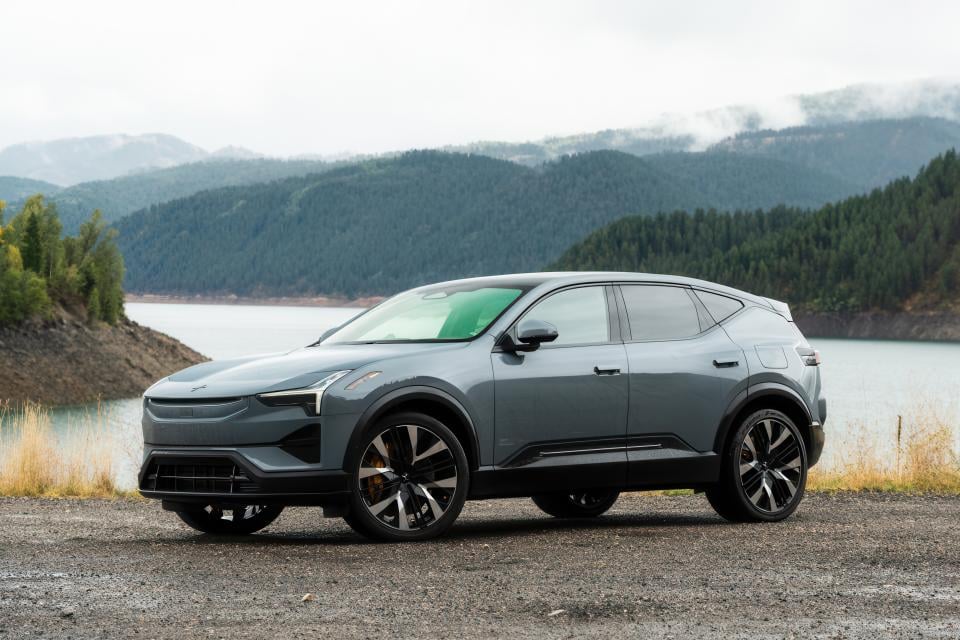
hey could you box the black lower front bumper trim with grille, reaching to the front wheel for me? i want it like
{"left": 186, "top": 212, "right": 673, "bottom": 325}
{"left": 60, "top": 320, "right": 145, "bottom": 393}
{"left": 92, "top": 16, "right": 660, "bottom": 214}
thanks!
{"left": 139, "top": 450, "right": 349, "bottom": 505}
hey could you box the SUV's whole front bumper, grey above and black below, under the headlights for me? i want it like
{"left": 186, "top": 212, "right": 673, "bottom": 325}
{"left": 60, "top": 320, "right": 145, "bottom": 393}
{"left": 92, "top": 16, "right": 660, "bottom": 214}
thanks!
{"left": 138, "top": 397, "right": 359, "bottom": 505}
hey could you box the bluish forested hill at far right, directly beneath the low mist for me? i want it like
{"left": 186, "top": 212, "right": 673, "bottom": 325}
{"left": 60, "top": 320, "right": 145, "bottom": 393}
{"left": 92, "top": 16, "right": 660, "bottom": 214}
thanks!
{"left": 712, "top": 118, "right": 960, "bottom": 189}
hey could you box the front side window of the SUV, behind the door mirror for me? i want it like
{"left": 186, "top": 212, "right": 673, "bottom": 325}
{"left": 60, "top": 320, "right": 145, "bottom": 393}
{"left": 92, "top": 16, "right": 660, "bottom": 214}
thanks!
{"left": 524, "top": 287, "right": 610, "bottom": 345}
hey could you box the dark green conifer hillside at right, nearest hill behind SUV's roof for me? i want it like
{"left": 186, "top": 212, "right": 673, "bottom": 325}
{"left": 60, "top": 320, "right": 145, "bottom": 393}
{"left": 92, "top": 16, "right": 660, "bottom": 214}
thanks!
{"left": 550, "top": 151, "right": 960, "bottom": 311}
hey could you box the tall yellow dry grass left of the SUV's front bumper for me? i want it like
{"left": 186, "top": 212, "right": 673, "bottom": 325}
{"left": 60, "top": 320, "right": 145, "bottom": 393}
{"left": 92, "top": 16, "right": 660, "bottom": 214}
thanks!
{"left": 0, "top": 405, "right": 123, "bottom": 498}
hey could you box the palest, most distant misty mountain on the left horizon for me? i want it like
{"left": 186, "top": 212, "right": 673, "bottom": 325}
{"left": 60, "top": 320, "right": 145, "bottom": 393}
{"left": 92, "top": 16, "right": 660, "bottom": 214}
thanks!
{"left": 0, "top": 133, "right": 256, "bottom": 186}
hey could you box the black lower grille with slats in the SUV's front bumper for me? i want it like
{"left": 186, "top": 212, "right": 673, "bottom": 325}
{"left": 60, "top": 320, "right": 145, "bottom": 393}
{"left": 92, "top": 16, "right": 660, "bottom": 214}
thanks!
{"left": 140, "top": 457, "right": 260, "bottom": 494}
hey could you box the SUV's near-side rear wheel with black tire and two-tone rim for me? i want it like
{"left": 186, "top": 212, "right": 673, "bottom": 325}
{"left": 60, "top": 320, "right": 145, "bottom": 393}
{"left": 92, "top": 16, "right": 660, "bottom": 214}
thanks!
{"left": 706, "top": 409, "right": 807, "bottom": 522}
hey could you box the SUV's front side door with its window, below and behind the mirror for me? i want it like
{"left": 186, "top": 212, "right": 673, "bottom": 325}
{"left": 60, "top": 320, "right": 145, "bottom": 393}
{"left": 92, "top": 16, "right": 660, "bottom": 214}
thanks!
{"left": 491, "top": 285, "right": 629, "bottom": 490}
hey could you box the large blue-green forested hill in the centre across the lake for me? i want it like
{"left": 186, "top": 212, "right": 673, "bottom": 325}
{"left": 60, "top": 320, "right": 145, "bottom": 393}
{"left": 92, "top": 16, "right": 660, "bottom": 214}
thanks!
{"left": 119, "top": 152, "right": 850, "bottom": 296}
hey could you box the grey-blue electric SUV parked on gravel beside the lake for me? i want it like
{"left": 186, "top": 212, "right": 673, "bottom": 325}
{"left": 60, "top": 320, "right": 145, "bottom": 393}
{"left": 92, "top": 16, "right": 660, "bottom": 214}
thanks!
{"left": 139, "top": 273, "right": 826, "bottom": 540}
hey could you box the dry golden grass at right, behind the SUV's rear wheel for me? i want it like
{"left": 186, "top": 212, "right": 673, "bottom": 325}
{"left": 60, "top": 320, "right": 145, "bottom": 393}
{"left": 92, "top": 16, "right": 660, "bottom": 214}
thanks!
{"left": 807, "top": 407, "right": 960, "bottom": 495}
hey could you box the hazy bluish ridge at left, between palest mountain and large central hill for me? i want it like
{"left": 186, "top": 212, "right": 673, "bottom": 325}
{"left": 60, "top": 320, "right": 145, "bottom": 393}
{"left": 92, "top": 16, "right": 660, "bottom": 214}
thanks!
{"left": 15, "top": 159, "right": 335, "bottom": 233}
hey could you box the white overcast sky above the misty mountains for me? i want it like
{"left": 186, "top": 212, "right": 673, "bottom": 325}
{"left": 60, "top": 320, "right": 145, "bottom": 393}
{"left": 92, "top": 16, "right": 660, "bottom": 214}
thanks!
{"left": 0, "top": 0, "right": 960, "bottom": 155}
